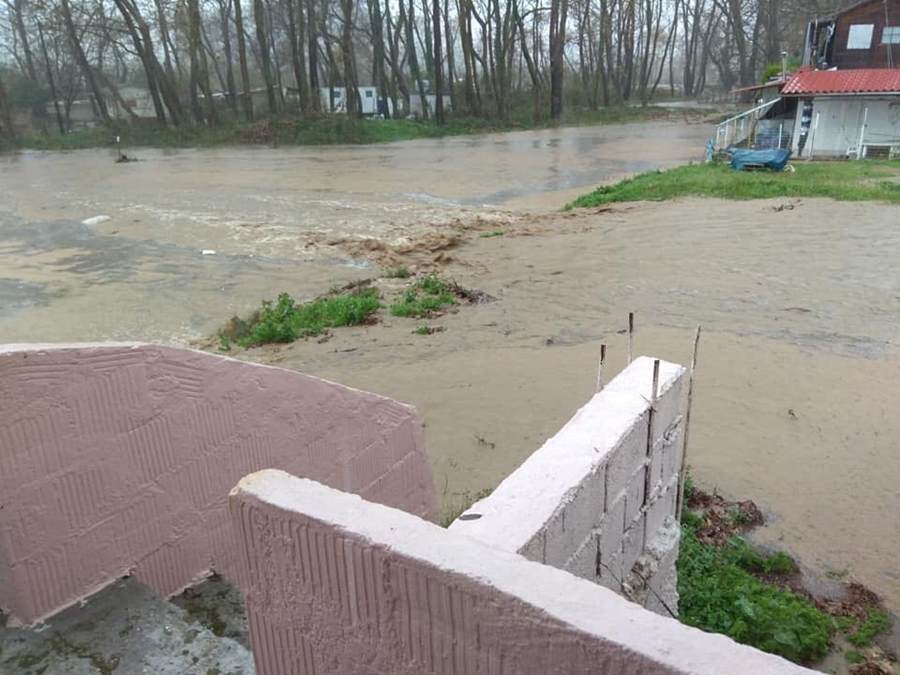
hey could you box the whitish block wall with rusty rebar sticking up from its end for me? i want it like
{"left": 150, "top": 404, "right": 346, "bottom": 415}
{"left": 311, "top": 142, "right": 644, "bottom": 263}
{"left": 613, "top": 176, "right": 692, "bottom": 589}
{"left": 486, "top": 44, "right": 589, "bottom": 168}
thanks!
{"left": 450, "top": 357, "right": 687, "bottom": 614}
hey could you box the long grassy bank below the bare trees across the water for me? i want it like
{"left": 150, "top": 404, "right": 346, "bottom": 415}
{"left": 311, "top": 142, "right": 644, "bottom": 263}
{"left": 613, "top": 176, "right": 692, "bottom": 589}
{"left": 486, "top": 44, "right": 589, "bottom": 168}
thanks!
{"left": 18, "top": 107, "right": 672, "bottom": 150}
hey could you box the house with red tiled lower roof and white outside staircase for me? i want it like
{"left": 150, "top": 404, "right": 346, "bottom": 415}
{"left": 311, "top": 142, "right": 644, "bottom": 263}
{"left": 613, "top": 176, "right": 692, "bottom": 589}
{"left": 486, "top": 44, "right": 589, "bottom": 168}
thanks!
{"left": 716, "top": 0, "right": 900, "bottom": 159}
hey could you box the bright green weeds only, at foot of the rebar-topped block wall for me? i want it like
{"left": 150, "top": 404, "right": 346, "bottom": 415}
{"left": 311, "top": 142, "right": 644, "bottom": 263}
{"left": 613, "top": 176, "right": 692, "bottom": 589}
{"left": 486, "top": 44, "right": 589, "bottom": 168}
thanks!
{"left": 678, "top": 525, "right": 834, "bottom": 663}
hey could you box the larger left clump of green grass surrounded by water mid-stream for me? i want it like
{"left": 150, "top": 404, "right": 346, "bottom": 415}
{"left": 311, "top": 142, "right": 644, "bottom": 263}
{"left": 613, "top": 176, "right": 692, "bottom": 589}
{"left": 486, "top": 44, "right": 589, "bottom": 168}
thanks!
{"left": 227, "top": 288, "right": 381, "bottom": 348}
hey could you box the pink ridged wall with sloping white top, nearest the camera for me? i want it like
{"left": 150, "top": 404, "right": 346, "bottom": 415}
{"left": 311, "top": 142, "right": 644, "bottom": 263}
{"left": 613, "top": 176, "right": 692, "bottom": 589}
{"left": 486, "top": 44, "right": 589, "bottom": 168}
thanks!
{"left": 230, "top": 471, "right": 812, "bottom": 675}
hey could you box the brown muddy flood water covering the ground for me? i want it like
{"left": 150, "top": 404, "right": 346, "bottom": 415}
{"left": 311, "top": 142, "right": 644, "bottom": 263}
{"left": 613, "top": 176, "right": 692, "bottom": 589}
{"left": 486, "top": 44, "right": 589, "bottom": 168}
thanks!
{"left": 0, "top": 121, "right": 900, "bottom": 611}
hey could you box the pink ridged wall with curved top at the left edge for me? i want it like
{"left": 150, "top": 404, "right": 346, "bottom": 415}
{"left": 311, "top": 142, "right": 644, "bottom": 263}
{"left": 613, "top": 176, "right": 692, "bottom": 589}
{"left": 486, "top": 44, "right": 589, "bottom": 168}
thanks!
{"left": 0, "top": 344, "right": 436, "bottom": 623}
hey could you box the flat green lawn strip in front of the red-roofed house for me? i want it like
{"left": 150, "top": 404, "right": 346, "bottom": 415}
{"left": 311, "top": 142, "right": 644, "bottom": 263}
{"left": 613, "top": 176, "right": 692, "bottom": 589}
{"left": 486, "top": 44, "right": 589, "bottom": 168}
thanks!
{"left": 567, "top": 160, "right": 900, "bottom": 209}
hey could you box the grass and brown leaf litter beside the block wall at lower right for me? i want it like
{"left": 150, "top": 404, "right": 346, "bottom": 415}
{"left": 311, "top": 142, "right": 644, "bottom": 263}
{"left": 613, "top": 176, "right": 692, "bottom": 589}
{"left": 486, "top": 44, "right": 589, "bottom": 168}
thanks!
{"left": 678, "top": 475, "right": 891, "bottom": 673}
